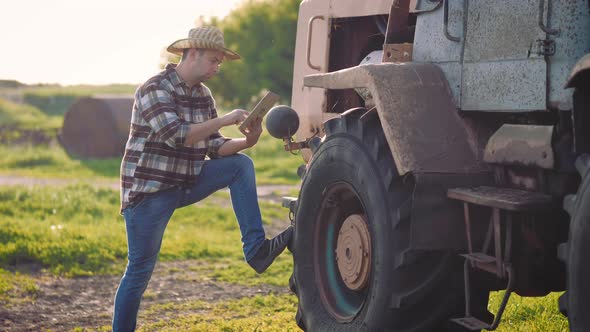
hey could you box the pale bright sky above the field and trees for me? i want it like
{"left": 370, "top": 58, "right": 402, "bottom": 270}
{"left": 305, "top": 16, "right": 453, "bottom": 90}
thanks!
{"left": 0, "top": 0, "right": 243, "bottom": 85}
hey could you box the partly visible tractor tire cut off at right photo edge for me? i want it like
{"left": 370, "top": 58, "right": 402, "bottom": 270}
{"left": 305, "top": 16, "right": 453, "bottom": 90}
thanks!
{"left": 558, "top": 154, "right": 590, "bottom": 332}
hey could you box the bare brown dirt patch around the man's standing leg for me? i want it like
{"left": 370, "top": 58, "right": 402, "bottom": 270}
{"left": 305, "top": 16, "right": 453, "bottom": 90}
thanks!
{"left": 0, "top": 261, "right": 288, "bottom": 331}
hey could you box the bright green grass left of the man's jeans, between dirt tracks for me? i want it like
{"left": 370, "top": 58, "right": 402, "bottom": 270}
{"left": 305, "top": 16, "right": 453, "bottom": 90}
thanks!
{"left": 0, "top": 185, "right": 126, "bottom": 275}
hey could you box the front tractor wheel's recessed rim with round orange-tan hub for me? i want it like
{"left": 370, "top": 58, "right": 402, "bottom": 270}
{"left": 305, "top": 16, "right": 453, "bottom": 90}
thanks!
{"left": 314, "top": 182, "right": 371, "bottom": 322}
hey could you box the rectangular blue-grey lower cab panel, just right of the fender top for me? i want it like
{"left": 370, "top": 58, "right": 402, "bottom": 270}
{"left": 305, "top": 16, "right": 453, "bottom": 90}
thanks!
{"left": 461, "top": 59, "right": 547, "bottom": 111}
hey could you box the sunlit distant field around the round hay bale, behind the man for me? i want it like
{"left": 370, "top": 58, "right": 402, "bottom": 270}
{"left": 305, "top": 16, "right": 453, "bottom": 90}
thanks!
{"left": 0, "top": 85, "right": 303, "bottom": 184}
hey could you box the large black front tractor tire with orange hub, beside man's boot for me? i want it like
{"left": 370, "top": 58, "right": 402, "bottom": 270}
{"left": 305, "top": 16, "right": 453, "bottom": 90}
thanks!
{"left": 290, "top": 108, "right": 480, "bottom": 332}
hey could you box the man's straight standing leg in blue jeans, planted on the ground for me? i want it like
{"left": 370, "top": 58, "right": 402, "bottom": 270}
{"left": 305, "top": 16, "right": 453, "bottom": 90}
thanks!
{"left": 113, "top": 190, "right": 180, "bottom": 332}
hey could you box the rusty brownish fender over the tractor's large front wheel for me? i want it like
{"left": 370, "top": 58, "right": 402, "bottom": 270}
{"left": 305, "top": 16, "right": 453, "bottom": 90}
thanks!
{"left": 304, "top": 63, "right": 479, "bottom": 175}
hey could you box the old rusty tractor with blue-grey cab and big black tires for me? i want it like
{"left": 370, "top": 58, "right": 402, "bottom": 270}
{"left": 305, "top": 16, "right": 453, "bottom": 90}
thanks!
{"left": 267, "top": 0, "right": 590, "bottom": 332}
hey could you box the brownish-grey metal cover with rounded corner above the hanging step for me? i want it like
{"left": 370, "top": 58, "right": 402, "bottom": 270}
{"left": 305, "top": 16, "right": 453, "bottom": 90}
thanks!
{"left": 484, "top": 124, "right": 555, "bottom": 169}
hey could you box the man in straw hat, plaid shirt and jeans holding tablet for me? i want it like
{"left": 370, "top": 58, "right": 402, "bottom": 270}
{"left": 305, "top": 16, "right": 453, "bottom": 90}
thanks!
{"left": 113, "top": 27, "right": 293, "bottom": 331}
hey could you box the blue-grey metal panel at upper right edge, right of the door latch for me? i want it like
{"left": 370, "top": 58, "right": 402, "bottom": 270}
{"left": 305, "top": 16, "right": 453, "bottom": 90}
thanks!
{"left": 548, "top": 0, "right": 590, "bottom": 110}
